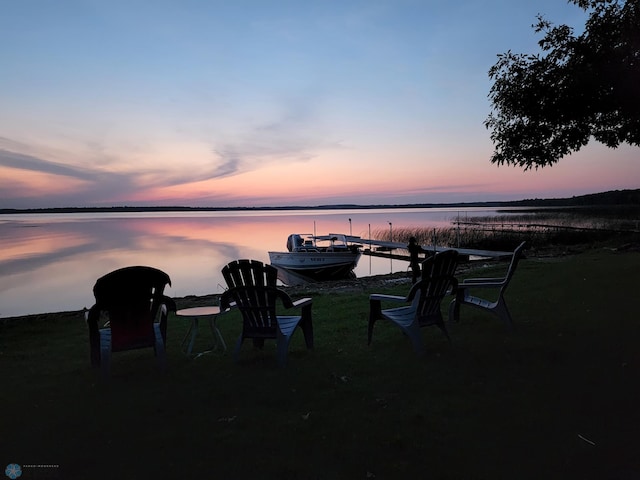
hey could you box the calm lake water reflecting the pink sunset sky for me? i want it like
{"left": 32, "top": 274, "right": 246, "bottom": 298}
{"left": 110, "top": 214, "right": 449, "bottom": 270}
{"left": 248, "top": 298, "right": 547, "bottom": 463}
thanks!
{"left": 0, "top": 208, "right": 516, "bottom": 318}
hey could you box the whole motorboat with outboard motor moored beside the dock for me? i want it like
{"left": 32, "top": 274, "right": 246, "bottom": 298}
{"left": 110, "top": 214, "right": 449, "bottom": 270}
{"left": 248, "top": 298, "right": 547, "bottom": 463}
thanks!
{"left": 269, "top": 233, "right": 362, "bottom": 280}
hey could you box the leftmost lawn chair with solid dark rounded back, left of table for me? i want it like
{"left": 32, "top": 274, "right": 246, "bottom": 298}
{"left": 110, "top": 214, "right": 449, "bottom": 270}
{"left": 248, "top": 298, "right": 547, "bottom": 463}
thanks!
{"left": 86, "top": 266, "right": 176, "bottom": 376}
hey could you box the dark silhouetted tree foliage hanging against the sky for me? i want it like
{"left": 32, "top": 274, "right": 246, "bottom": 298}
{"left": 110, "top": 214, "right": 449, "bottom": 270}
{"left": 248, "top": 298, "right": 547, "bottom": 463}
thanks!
{"left": 485, "top": 0, "right": 640, "bottom": 170}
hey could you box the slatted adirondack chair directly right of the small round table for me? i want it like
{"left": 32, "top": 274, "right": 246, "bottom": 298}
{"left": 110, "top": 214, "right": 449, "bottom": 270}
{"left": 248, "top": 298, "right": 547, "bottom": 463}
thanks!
{"left": 220, "top": 259, "right": 313, "bottom": 367}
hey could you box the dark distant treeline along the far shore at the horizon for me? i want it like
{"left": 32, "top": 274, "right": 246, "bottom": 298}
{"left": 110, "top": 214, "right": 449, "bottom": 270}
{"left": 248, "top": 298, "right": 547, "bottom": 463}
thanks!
{"left": 0, "top": 189, "right": 640, "bottom": 214}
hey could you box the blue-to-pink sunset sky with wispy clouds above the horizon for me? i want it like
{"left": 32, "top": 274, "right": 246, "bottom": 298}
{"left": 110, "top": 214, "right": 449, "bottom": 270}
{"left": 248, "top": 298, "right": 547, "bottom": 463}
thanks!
{"left": 0, "top": 0, "right": 640, "bottom": 208}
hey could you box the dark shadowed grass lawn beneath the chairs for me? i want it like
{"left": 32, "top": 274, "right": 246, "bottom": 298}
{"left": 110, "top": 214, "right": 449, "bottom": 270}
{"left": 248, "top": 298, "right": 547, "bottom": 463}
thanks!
{"left": 0, "top": 248, "right": 640, "bottom": 480}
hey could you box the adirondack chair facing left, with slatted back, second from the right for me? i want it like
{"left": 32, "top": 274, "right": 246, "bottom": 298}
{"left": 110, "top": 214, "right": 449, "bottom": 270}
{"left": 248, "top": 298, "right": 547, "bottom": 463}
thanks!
{"left": 368, "top": 250, "right": 458, "bottom": 356}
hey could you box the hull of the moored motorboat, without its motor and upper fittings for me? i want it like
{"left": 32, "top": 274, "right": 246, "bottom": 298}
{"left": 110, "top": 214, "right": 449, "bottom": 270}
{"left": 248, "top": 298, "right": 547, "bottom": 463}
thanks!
{"left": 269, "top": 252, "right": 361, "bottom": 280}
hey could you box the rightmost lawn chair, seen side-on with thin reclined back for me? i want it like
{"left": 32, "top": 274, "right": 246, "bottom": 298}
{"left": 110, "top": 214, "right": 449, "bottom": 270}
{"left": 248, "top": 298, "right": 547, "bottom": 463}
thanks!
{"left": 449, "top": 241, "right": 527, "bottom": 327}
